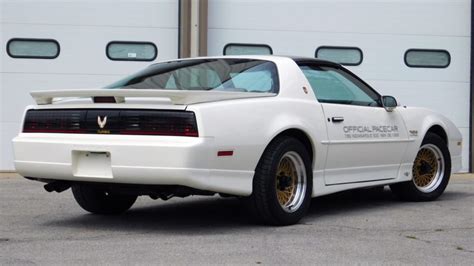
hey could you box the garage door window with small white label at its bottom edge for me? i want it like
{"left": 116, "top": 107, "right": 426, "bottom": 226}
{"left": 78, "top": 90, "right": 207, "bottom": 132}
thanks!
{"left": 106, "top": 41, "right": 158, "bottom": 61}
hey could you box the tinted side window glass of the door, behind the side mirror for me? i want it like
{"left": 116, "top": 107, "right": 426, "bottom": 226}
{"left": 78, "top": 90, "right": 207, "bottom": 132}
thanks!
{"left": 300, "top": 66, "right": 379, "bottom": 106}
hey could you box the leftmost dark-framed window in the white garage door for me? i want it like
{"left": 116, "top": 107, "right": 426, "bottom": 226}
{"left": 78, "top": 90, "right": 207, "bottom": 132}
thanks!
{"left": 7, "top": 38, "right": 60, "bottom": 59}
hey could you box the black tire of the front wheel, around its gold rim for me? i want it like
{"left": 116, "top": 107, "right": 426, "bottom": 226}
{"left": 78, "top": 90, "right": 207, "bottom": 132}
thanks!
{"left": 390, "top": 132, "right": 451, "bottom": 201}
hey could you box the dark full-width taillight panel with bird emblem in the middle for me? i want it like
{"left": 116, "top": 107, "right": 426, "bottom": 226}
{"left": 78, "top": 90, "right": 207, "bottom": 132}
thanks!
{"left": 23, "top": 109, "right": 199, "bottom": 137}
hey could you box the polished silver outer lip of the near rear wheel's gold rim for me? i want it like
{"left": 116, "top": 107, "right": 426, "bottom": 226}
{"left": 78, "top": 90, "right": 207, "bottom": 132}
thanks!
{"left": 275, "top": 151, "right": 307, "bottom": 213}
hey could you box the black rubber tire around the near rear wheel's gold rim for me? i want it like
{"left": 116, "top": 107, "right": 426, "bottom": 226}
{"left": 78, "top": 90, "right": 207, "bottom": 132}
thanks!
{"left": 246, "top": 137, "right": 313, "bottom": 225}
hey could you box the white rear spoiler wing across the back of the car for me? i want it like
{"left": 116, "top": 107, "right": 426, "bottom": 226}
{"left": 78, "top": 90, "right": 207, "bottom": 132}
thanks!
{"left": 30, "top": 89, "right": 276, "bottom": 105}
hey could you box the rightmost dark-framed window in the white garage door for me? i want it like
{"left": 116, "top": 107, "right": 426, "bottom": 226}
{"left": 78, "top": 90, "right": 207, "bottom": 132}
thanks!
{"left": 405, "top": 49, "right": 451, "bottom": 68}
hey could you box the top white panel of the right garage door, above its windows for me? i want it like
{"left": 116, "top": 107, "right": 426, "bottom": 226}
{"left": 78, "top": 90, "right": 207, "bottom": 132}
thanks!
{"left": 209, "top": 0, "right": 470, "bottom": 36}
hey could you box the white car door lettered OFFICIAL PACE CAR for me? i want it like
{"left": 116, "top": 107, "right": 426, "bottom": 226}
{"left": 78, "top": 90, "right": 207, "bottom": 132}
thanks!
{"left": 322, "top": 103, "right": 409, "bottom": 184}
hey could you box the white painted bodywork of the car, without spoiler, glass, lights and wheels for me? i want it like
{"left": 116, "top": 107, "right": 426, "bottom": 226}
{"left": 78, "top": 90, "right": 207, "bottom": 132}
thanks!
{"left": 14, "top": 56, "right": 461, "bottom": 196}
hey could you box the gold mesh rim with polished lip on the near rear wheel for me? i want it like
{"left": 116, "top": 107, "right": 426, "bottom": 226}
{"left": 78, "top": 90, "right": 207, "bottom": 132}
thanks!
{"left": 275, "top": 152, "right": 306, "bottom": 212}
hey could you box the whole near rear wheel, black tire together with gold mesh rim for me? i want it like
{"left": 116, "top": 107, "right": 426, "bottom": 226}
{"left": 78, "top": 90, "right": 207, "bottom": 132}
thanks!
{"left": 248, "top": 137, "right": 313, "bottom": 225}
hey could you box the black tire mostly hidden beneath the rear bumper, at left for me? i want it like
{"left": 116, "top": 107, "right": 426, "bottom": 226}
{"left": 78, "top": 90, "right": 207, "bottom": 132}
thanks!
{"left": 72, "top": 184, "right": 137, "bottom": 215}
